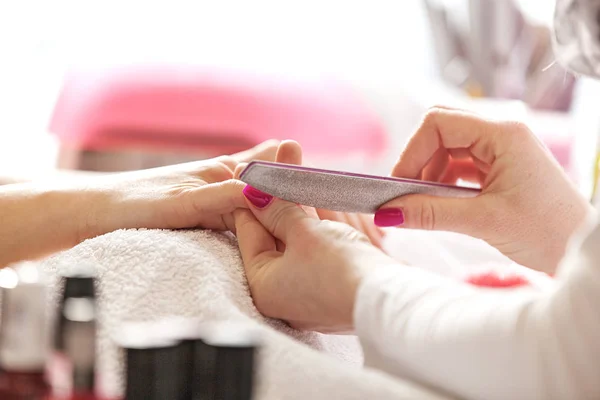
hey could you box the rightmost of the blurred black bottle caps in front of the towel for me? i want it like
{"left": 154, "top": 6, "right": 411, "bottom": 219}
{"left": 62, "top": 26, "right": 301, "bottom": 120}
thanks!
{"left": 193, "top": 322, "right": 260, "bottom": 400}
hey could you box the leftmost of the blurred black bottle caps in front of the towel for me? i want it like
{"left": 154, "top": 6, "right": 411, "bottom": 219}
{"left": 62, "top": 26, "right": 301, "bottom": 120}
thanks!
{"left": 114, "top": 323, "right": 189, "bottom": 400}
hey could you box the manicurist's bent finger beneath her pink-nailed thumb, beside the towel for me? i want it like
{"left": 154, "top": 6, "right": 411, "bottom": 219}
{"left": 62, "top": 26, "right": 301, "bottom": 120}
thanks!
{"left": 233, "top": 208, "right": 279, "bottom": 280}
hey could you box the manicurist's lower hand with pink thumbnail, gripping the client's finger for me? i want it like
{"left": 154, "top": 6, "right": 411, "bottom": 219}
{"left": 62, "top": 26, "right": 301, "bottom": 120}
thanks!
{"left": 234, "top": 192, "right": 394, "bottom": 332}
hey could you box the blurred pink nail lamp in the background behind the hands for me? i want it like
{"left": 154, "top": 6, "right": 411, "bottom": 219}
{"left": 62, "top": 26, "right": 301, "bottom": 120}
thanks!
{"left": 50, "top": 67, "right": 386, "bottom": 169}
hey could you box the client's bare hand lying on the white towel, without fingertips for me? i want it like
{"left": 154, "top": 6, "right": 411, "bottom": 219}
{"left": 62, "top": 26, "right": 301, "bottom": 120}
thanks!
{"left": 77, "top": 141, "right": 278, "bottom": 239}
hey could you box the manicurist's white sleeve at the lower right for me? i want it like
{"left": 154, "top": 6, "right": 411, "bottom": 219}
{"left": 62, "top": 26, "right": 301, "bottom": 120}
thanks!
{"left": 354, "top": 214, "right": 600, "bottom": 400}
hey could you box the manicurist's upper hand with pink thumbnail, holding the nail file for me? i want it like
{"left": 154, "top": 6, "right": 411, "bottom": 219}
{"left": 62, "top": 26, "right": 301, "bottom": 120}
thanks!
{"left": 375, "top": 107, "right": 591, "bottom": 273}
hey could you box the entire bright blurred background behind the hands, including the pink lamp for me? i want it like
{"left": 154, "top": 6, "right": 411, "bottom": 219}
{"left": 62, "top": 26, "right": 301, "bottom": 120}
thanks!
{"left": 0, "top": 0, "right": 600, "bottom": 196}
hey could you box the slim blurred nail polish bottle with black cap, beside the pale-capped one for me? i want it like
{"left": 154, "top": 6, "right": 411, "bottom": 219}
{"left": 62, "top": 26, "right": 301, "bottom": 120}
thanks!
{"left": 49, "top": 268, "right": 99, "bottom": 400}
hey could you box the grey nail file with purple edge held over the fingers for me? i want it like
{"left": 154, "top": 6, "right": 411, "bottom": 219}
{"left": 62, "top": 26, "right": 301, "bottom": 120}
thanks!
{"left": 240, "top": 161, "right": 480, "bottom": 214}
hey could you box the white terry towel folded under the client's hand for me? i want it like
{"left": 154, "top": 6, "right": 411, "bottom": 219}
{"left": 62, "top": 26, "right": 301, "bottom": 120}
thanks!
{"left": 43, "top": 230, "right": 447, "bottom": 400}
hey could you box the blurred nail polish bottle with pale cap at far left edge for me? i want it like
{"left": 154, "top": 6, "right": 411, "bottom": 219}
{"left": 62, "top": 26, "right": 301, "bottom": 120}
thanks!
{"left": 0, "top": 264, "right": 50, "bottom": 400}
